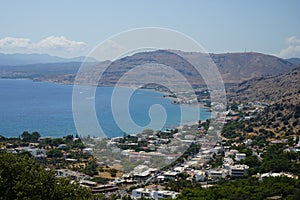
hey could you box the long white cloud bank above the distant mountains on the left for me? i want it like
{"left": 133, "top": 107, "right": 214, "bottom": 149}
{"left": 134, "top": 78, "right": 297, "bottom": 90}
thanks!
{"left": 0, "top": 36, "right": 88, "bottom": 57}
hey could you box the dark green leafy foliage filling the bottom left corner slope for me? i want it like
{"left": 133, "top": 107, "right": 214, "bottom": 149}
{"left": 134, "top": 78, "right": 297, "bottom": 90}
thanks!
{"left": 0, "top": 153, "right": 93, "bottom": 200}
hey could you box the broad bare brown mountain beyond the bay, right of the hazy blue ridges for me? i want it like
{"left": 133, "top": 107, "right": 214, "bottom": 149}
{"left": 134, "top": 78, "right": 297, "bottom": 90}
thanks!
{"left": 97, "top": 50, "right": 296, "bottom": 84}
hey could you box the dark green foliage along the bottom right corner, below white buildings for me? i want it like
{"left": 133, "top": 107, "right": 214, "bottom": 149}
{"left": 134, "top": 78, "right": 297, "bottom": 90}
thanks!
{"left": 177, "top": 177, "right": 300, "bottom": 200}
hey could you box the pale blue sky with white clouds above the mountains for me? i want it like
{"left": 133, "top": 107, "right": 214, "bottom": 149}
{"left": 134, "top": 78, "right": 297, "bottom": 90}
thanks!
{"left": 0, "top": 0, "right": 300, "bottom": 58}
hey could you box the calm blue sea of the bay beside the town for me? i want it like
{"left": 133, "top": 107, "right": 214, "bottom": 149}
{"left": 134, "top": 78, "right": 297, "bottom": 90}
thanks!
{"left": 0, "top": 79, "right": 210, "bottom": 137}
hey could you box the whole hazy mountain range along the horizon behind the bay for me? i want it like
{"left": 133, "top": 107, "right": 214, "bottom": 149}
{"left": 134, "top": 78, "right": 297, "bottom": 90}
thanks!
{"left": 0, "top": 50, "right": 300, "bottom": 85}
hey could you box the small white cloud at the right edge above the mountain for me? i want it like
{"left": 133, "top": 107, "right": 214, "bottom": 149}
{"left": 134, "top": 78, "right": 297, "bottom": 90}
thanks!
{"left": 278, "top": 36, "right": 300, "bottom": 58}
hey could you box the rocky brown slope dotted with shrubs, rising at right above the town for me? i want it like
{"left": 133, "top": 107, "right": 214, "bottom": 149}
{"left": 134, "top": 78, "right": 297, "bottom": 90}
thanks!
{"left": 227, "top": 67, "right": 300, "bottom": 141}
